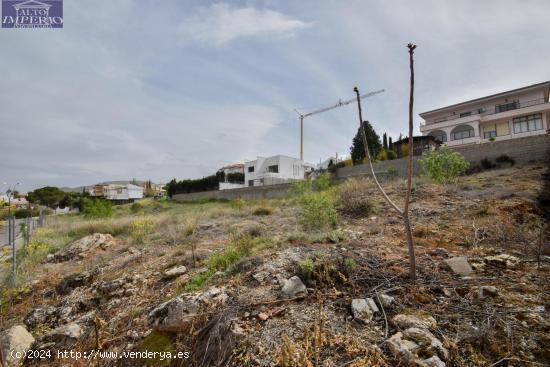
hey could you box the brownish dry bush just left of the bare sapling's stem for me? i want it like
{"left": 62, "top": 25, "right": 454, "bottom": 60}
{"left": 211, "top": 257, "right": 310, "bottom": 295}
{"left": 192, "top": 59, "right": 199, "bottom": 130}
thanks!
{"left": 338, "top": 178, "right": 375, "bottom": 217}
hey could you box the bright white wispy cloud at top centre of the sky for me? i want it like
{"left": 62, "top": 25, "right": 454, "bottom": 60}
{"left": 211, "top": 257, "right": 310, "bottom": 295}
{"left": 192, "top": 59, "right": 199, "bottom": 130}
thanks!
{"left": 180, "top": 3, "right": 311, "bottom": 45}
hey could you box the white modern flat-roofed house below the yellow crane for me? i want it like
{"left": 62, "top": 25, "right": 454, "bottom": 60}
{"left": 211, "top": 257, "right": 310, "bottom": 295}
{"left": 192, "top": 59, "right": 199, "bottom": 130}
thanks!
{"left": 244, "top": 155, "right": 315, "bottom": 186}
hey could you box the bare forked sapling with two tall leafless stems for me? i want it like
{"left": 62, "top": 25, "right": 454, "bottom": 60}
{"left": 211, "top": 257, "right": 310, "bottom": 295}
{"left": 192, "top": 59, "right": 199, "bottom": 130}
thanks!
{"left": 353, "top": 43, "right": 416, "bottom": 281}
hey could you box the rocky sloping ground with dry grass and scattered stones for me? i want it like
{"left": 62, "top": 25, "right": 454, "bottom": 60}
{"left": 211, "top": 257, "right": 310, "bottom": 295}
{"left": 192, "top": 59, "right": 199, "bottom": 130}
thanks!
{"left": 0, "top": 164, "right": 550, "bottom": 367}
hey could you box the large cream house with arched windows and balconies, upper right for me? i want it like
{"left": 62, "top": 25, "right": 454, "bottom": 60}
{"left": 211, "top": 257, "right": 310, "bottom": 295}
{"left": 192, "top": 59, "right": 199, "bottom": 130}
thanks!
{"left": 420, "top": 81, "right": 550, "bottom": 146}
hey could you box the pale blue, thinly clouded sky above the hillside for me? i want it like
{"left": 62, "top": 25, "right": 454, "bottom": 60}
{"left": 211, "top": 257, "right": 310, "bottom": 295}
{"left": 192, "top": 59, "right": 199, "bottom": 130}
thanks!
{"left": 0, "top": 0, "right": 550, "bottom": 191}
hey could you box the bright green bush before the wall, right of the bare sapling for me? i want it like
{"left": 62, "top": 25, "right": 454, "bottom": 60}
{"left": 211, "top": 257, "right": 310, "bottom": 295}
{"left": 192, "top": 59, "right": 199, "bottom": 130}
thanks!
{"left": 419, "top": 148, "right": 470, "bottom": 184}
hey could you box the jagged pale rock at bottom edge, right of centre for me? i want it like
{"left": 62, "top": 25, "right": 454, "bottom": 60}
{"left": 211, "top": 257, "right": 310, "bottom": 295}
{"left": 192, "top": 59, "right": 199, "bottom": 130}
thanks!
{"left": 387, "top": 328, "right": 449, "bottom": 367}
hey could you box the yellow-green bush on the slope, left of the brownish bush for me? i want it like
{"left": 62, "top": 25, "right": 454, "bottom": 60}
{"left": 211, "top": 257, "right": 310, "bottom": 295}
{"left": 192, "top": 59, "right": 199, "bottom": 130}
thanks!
{"left": 301, "top": 192, "right": 338, "bottom": 228}
